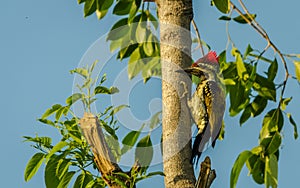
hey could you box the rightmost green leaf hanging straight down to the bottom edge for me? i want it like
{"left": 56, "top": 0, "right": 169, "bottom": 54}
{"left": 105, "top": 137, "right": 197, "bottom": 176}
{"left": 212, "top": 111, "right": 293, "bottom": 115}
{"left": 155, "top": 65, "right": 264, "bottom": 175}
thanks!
{"left": 265, "top": 154, "right": 278, "bottom": 188}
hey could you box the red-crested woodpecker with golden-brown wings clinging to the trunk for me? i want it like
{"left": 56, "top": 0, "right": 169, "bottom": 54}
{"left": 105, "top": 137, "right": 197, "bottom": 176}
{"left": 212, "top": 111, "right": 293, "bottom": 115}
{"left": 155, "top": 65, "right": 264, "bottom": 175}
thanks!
{"left": 184, "top": 51, "right": 225, "bottom": 164}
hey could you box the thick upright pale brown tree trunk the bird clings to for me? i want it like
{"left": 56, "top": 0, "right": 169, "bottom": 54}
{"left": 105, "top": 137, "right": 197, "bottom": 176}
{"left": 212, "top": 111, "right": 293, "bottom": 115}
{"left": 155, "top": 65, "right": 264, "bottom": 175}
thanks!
{"left": 156, "top": 0, "right": 195, "bottom": 188}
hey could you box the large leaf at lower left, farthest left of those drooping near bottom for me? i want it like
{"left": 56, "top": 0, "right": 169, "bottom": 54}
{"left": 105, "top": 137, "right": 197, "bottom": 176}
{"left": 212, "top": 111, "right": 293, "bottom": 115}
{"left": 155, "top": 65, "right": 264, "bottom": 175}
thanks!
{"left": 24, "top": 153, "right": 45, "bottom": 181}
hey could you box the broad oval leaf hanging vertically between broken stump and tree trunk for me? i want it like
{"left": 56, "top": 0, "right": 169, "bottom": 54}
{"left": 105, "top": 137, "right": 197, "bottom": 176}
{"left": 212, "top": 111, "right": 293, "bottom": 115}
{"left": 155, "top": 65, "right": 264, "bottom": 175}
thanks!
{"left": 135, "top": 135, "right": 153, "bottom": 171}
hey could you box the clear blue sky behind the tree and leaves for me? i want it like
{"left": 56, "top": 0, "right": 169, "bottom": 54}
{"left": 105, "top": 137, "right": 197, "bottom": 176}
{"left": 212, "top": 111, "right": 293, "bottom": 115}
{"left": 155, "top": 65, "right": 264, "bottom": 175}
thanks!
{"left": 0, "top": 0, "right": 300, "bottom": 188}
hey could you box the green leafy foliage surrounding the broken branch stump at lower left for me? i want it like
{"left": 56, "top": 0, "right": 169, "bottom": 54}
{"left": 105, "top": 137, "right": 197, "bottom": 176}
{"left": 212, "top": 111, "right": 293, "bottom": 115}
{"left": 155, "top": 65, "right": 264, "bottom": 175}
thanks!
{"left": 24, "top": 62, "right": 163, "bottom": 188}
